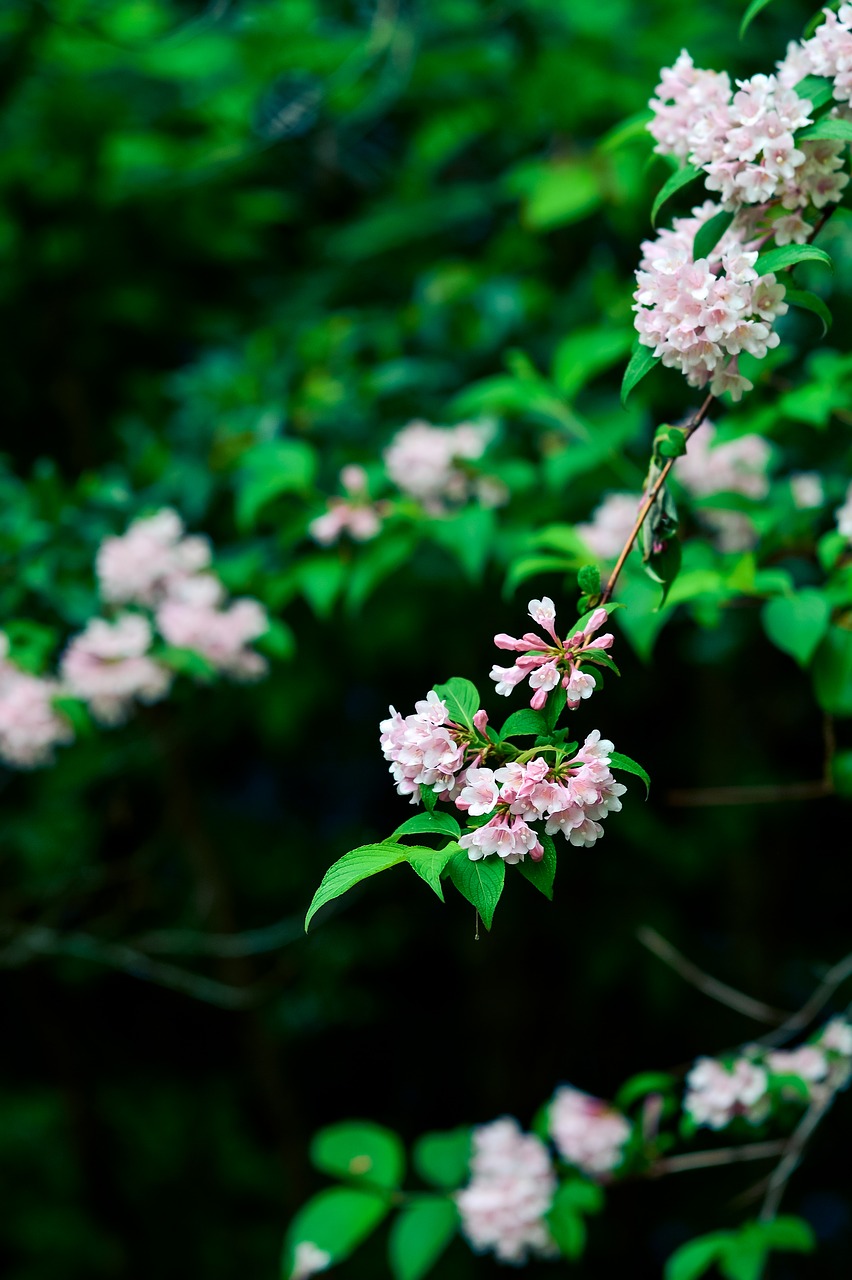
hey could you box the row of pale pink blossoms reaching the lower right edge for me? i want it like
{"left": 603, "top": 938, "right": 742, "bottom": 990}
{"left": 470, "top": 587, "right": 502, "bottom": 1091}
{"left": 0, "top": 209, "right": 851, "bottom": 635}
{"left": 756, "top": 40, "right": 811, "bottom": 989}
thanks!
{"left": 683, "top": 1018, "right": 852, "bottom": 1129}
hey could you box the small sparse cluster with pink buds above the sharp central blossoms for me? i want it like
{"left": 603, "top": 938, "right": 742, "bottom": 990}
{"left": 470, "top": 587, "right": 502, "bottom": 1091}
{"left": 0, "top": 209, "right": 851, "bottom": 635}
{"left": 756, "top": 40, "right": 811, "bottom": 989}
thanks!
{"left": 491, "top": 595, "right": 613, "bottom": 710}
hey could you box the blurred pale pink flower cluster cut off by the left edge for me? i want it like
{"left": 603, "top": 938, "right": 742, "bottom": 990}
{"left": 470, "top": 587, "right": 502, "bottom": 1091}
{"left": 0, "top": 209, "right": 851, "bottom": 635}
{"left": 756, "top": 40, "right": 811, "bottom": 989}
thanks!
{"left": 0, "top": 632, "right": 74, "bottom": 769}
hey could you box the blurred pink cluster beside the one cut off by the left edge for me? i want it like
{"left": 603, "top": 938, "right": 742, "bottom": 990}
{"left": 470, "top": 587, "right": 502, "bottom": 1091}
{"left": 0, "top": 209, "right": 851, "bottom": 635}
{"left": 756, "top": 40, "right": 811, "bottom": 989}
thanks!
{"left": 60, "top": 613, "right": 171, "bottom": 724}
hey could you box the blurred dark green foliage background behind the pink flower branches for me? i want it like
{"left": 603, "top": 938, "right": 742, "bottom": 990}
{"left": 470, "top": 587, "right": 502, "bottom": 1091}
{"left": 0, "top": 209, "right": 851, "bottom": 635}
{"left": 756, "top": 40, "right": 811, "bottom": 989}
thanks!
{"left": 0, "top": 0, "right": 852, "bottom": 1280}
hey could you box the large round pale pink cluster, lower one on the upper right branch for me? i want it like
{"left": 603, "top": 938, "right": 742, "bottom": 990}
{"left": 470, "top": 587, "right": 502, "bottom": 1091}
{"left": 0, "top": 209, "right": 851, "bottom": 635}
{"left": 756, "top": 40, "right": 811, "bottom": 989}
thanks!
{"left": 633, "top": 201, "right": 788, "bottom": 401}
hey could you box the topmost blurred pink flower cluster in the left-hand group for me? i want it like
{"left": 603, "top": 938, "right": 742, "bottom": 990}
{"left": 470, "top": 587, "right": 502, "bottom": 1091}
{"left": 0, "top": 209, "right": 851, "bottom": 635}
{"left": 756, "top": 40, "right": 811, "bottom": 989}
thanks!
{"left": 96, "top": 507, "right": 210, "bottom": 605}
